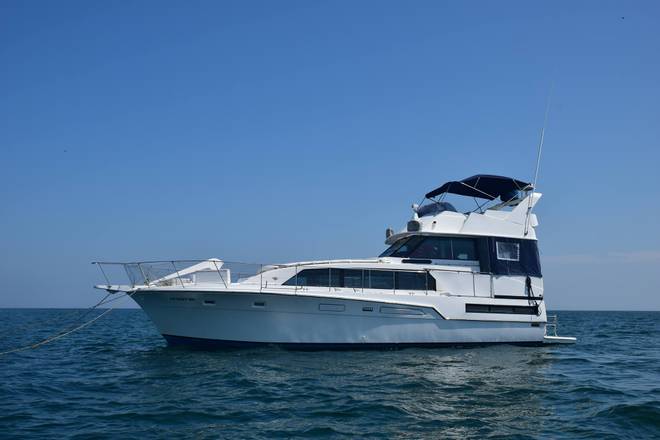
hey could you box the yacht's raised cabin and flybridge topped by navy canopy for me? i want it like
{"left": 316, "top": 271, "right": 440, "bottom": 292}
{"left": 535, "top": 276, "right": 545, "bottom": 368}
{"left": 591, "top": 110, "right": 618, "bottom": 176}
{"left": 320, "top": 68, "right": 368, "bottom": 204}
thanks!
{"left": 381, "top": 175, "right": 543, "bottom": 296}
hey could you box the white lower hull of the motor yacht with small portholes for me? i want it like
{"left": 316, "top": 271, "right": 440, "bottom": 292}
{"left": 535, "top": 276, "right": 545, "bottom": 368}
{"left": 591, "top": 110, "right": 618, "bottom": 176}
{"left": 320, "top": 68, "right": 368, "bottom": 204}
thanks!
{"left": 133, "top": 291, "right": 545, "bottom": 348}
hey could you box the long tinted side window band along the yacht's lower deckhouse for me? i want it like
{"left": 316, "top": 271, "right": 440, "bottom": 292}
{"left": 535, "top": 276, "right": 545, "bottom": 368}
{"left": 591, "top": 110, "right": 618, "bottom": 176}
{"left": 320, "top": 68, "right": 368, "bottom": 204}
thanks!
{"left": 284, "top": 268, "right": 436, "bottom": 290}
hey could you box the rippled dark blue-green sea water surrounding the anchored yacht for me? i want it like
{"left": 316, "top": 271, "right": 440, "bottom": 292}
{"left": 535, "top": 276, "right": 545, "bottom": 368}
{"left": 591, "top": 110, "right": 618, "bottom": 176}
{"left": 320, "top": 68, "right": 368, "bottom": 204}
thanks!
{"left": 0, "top": 309, "right": 660, "bottom": 439}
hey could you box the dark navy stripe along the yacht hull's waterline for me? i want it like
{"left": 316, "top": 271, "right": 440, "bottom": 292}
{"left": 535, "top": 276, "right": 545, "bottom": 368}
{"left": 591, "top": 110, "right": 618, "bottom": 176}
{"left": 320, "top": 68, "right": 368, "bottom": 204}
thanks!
{"left": 163, "top": 335, "right": 543, "bottom": 351}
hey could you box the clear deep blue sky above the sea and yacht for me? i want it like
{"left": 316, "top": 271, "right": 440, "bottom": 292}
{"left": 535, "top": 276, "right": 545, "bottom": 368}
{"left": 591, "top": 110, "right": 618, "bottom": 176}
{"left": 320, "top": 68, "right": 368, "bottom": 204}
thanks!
{"left": 0, "top": 1, "right": 660, "bottom": 309}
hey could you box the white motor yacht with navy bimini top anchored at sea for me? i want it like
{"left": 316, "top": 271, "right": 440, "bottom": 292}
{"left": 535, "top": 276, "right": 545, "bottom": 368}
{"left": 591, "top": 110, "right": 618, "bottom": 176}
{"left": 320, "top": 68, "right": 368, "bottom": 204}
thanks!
{"left": 94, "top": 175, "right": 575, "bottom": 349}
